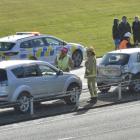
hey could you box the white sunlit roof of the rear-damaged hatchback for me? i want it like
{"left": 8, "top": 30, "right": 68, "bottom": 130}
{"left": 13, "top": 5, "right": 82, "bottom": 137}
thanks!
{"left": 108, "top": 48, "right": 140, "bottom": 54}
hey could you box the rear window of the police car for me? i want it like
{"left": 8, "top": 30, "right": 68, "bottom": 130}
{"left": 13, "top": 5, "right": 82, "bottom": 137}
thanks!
{"left": 0, "top": 42, "right": 15, "bottom": 51}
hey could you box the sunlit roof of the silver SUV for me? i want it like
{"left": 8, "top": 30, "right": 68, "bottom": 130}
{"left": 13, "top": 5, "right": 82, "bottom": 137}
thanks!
{"left": 0, "top": 60, "right": 43, "bottom": 69}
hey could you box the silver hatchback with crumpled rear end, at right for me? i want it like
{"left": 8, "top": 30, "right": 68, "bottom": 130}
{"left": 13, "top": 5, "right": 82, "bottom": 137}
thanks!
{"left": 97, "top": 48, "right": 140, "bottom": 92}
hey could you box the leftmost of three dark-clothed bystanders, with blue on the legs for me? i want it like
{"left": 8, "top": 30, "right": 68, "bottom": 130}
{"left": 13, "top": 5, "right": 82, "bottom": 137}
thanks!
{"left": 112, "top": 18, "right": 120, "bottom": 50}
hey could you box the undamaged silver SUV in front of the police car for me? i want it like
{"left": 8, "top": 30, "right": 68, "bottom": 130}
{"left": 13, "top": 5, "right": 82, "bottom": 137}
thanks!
{"left": 0, "top": 60, "right": 82, "bottom": 113}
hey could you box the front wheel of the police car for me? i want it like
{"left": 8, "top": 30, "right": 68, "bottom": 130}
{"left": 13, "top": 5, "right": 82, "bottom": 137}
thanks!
{"left": 72, "top": 50, "right": 83, "bottom": 67}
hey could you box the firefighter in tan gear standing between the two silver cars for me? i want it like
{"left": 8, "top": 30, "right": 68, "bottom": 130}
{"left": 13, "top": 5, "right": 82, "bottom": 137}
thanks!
{"left": 85, "top": 47, "right": 98, "bottom": 103}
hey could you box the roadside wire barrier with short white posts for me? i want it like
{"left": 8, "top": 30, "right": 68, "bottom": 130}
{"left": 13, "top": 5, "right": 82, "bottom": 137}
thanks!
{"left": 0, "top": 79, "right": 140, "bottom": 115}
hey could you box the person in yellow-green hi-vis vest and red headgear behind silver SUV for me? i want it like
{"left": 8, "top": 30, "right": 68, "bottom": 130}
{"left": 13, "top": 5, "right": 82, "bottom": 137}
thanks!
{"left": 55, "top": 47, "right": 73, "bottom": 72}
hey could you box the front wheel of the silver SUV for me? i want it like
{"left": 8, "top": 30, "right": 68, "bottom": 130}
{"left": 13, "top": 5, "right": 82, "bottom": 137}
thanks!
{"left": 64, "top": 83, "right": 81, "bottom": 105}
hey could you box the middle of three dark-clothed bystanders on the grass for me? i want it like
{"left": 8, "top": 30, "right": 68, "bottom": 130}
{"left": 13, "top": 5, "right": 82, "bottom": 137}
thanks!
{"left": 119, "top": 16, "right": 131, "bottom": 41}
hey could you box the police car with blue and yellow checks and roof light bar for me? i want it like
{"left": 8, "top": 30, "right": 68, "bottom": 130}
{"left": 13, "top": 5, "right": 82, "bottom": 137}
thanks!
{"left": 0, "top": 32, "right": 85, "bottom": 67}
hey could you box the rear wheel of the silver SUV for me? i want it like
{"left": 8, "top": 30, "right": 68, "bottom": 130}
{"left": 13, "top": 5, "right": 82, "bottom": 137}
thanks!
{"left": 15, "top": 92, "right": 30, "bottom": 113}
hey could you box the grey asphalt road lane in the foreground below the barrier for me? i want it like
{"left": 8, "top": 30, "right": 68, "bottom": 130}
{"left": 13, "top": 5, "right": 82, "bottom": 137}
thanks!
{"left": 0, "top": 101, "right": 140, "bottom": 140}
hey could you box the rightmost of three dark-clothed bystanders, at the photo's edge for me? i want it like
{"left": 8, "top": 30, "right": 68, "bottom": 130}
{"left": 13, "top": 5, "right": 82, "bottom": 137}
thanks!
{"left": 132, "top": 16, "right": 140, "bottom": 46}
